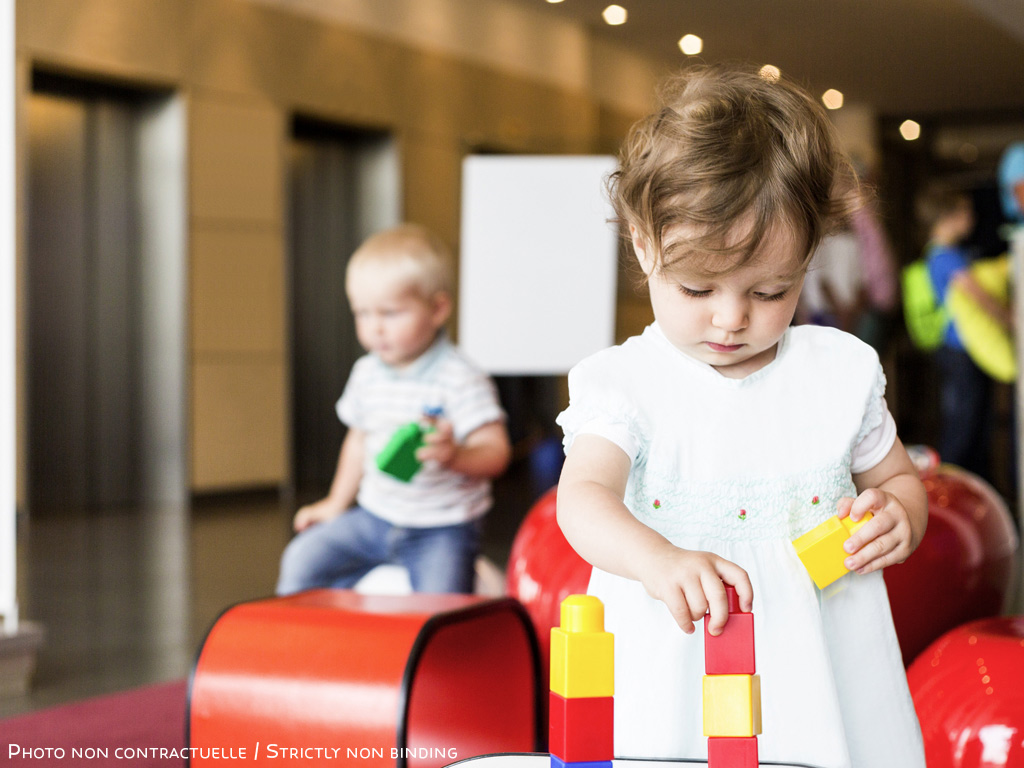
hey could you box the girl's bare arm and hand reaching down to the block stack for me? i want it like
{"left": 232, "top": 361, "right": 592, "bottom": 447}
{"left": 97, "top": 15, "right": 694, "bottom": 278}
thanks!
{"left": 557, "top": 434, "right": 754, "bottom": 635}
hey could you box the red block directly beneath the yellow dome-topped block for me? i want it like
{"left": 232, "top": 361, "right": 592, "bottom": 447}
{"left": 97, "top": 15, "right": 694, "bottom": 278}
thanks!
{"left": 548, "top": 691, "right": 614, "bottom": 763}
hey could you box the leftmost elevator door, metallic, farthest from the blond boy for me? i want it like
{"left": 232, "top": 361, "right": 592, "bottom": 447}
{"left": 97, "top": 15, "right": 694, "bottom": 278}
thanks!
{"left": 26, "top": 75, "right": 185, "bottom": 513}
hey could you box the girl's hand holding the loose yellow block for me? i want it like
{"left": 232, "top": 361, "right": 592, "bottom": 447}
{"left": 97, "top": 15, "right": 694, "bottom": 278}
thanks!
{"left": 838, "top": 488, "right": 918, "bottom": 573}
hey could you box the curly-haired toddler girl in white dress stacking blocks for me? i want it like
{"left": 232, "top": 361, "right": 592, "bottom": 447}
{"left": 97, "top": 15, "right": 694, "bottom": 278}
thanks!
{"left": 558, "top": 68, "right": 927, "bottom": 768}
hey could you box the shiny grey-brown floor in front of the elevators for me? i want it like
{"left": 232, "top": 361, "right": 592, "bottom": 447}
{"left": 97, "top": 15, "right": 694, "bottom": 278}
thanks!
{"left": 0, "top": 456, "right": 536, "bottom": 718}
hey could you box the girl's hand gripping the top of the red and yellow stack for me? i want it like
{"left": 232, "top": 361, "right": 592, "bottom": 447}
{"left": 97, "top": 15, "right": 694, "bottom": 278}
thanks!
{"left": 640, "top": 545, "right": 754, "bottom": 636}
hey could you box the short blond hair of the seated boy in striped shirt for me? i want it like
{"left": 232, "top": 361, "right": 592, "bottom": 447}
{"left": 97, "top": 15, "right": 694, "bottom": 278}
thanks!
{"left": 345, "top": 223, "right": 453, "bottom": 299}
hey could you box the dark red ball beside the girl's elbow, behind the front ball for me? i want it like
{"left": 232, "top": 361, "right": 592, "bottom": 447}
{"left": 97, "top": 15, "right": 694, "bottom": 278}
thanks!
{"left": 885, "top": 464, "right": 1018, "bottom": 665}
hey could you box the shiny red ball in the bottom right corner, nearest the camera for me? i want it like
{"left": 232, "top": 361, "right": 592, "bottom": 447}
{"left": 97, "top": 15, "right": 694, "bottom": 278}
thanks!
{"left": 907, "top": 616, "right": 1024, "bottom": 768}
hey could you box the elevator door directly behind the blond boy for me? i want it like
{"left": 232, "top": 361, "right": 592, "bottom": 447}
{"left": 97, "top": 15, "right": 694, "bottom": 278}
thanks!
{"left": 290, "top": 119, "right": 400, "bottom": 495}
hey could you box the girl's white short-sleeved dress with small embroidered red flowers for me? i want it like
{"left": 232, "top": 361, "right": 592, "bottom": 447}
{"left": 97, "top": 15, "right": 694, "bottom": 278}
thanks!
{"left": 558, "top": 324, "right": 925, "bottom": 768}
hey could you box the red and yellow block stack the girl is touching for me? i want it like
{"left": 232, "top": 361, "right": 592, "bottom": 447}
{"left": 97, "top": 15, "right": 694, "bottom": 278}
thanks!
{"left": 703, "top": 585, "right": 761, "bottom": 768}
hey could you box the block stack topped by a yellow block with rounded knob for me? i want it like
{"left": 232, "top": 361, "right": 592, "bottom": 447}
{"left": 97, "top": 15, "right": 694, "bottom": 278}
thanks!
{"left": 548, "top": 595, "right": 614, "bottom": 768}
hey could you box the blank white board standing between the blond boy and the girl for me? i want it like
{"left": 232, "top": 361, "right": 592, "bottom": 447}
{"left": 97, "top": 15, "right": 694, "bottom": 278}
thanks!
{"left": 459, "top": 156, "right": 618, "bottom": 376}
